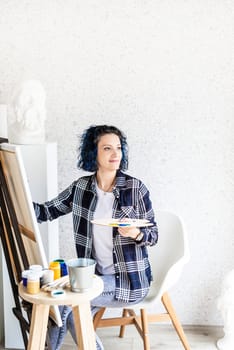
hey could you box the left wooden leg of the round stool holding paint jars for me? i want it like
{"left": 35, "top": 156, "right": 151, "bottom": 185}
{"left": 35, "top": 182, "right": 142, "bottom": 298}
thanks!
{"left": 27, "top": 304, "right": 50, "bottom": 350}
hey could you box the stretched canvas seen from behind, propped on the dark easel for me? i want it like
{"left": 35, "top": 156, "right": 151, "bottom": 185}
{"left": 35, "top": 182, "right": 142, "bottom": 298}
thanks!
{"left": 0, "top": 143, "right": 61, "bottom": 344}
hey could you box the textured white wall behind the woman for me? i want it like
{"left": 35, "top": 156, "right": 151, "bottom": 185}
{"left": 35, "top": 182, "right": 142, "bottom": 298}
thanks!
{"left": 0, "top": 0, "right": 234, "bottom": 324}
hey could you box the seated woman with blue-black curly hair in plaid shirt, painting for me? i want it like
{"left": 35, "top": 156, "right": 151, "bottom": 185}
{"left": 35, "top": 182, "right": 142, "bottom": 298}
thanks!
{"left": 34, "top": 125, "right": 158, "bottom": 349}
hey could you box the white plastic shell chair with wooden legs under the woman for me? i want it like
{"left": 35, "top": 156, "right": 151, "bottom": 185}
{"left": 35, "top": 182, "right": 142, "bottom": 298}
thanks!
{"left": 94, "top": 211, "right": 190, "bottom": 350}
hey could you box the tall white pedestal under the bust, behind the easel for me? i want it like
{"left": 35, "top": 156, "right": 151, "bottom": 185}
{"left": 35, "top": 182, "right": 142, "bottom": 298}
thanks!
{"left": 0, "top": 143, "right": 59, "bottom": 349}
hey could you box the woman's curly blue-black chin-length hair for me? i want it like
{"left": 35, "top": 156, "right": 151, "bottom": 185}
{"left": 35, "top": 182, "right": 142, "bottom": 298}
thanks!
{"left": 77, "top": 125, "right": 128, "bottom": 172}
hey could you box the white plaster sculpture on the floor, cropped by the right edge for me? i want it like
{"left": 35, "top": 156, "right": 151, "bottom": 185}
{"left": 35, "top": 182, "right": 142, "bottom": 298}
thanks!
{"left": 217, "top": 270, "right": 234, "bottom": 350}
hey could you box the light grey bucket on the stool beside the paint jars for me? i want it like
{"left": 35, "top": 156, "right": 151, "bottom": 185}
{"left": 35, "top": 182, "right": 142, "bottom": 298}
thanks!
{"left": 66, "top": 258, "right": 96, "bottom": 293}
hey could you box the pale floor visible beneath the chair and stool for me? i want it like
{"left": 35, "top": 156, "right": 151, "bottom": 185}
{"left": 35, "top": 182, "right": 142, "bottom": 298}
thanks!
{"left": 0, "top": 324, "right": 223, "bottom": 350}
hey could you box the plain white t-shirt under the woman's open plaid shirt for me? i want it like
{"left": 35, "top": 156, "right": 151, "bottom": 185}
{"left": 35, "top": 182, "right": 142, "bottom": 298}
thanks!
{"left": 93, "top": 184, "right": 114, "bottom": 275}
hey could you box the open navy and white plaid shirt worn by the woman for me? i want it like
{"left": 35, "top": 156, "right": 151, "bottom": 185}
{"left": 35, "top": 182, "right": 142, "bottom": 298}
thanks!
{"left": 34, "top": 171, "right": 158, "bottom": 302}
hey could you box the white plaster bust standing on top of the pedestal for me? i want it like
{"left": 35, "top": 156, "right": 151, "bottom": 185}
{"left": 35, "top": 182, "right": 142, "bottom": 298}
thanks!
{"left": 8, "top": 80, "right": 46, "bottom": 144}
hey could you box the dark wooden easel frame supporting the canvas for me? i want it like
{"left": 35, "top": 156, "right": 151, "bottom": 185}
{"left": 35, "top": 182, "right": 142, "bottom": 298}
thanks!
{"left": 0, "top": 138, "right": 30, "bottom": 349}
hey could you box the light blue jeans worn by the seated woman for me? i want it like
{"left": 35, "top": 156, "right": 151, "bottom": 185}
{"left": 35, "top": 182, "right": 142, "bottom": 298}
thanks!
{"left": 49, "top": 275, "right": 143, "bottom": 350}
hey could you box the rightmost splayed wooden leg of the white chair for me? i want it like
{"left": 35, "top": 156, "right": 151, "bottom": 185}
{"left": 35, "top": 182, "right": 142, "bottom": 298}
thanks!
{"left": 162, "top": 293, "right": 190, "bottom": 350}
